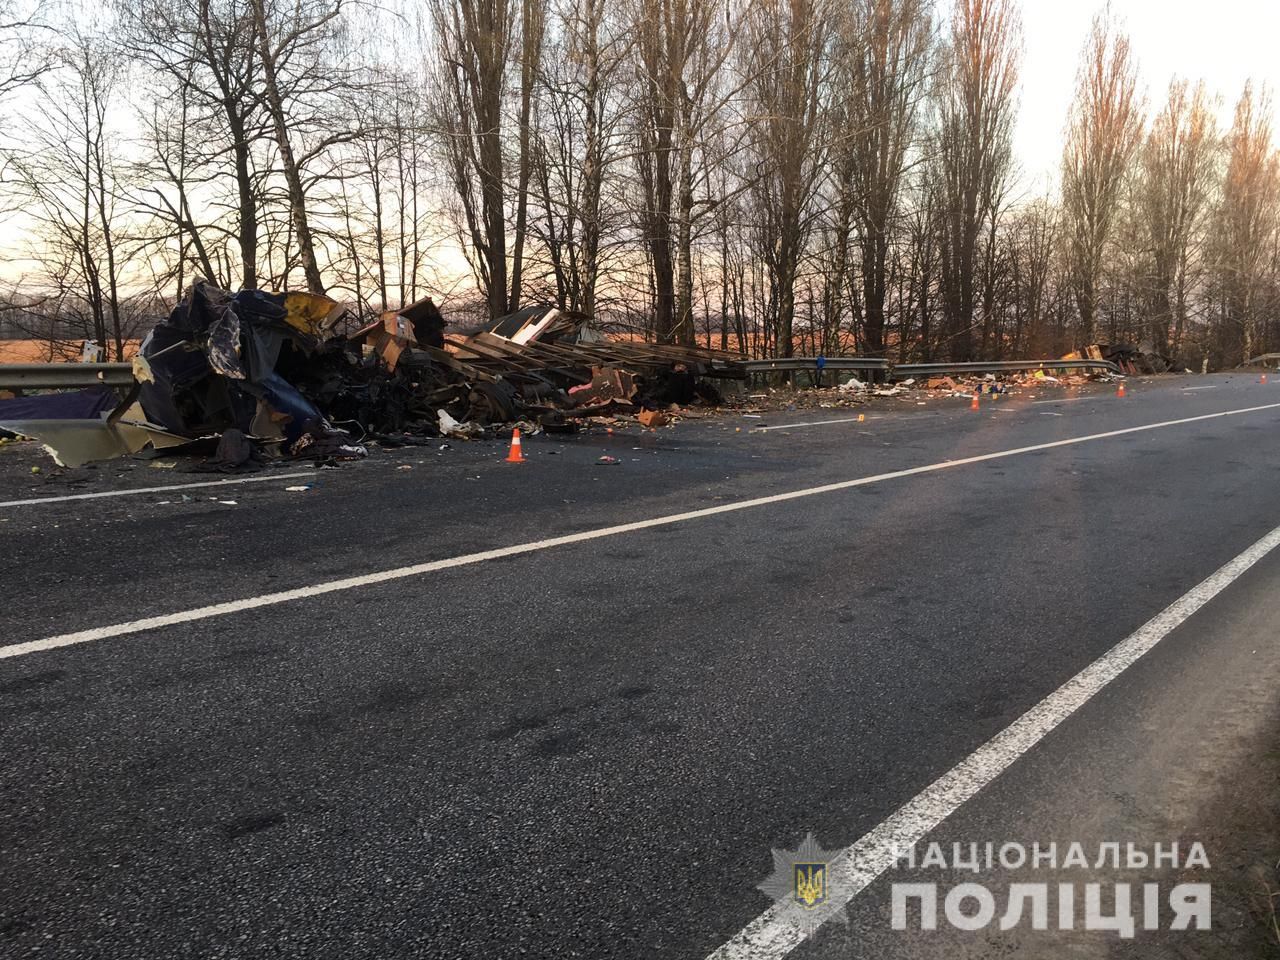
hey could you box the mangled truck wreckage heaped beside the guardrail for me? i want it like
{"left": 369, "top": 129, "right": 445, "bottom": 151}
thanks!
{"left": 0, "top": 282, "right": 745, "bottom": 468}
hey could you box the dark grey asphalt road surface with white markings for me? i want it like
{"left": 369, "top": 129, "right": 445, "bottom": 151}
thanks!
{"left": 0, "top": 375, "right": 1280, "bottom": 960}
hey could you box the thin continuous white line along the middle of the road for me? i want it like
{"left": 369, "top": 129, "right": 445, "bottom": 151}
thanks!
{"left": 0, "top": 403, "right": 1280, "bottom": 659}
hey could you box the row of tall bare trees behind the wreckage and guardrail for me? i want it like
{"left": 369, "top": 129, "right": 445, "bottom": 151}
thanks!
{"left": 0, "top": 0, "right": 1280, "bottom": 366}
